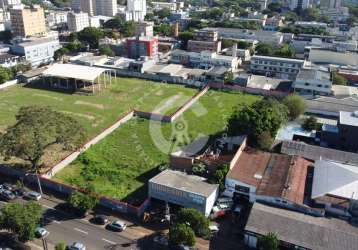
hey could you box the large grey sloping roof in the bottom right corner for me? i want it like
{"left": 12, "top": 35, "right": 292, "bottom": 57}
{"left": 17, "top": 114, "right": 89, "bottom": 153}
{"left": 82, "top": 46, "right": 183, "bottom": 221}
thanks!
{"left": 245, "top": 203, "right": 358, "bottom": 250}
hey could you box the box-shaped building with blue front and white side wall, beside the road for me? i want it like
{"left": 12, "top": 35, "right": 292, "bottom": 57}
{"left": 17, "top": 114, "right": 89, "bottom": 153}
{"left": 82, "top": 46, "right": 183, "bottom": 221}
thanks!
{"left": 148, "top": 170, "right": 219, "bottom": 216}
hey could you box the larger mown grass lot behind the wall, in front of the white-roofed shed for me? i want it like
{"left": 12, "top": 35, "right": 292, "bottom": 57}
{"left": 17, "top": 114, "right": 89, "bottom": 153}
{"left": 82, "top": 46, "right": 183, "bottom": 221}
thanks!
{"left": 0, "top": 78, "right": 197, "bottom": 166}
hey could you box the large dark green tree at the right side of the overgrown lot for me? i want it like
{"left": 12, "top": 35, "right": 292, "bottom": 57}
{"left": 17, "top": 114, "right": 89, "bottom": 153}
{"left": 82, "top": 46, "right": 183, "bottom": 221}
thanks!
{"left": 228, "top": 98, "right": 288, "bottom": 144}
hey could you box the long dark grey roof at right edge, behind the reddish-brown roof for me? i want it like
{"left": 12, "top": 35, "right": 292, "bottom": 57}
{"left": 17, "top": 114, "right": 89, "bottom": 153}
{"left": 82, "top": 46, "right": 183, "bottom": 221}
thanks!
{"left": 281, "top": 141, "right": 358, "bottom": 165}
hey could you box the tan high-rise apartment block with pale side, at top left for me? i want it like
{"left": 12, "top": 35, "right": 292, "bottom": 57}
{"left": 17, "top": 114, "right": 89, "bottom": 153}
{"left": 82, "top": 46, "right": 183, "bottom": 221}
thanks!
{"left": 10, "top": 5, "right": 46, "bottom": 37}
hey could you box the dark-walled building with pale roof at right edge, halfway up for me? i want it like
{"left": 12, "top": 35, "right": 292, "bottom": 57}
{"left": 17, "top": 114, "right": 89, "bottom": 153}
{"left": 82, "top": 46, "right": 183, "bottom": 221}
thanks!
{"left": 321, "top": 111, "right": 358, "bottom": 152}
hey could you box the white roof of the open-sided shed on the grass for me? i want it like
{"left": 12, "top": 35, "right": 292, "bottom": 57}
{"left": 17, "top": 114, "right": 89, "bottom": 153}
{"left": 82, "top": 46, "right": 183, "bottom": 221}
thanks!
{"left": 42, "top": 63, "right": 107, "bottom": 81}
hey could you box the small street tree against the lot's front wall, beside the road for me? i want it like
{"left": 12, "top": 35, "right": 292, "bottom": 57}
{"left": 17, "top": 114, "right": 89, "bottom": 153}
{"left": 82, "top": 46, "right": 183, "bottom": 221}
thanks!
{"left": 68, "top": 191, "right": 98, "bottom": 214}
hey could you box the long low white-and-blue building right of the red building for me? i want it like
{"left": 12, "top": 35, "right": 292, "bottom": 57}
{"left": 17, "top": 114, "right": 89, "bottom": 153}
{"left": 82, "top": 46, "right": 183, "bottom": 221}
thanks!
{"left": 170, "top": 49, "right": 241, "bottom": 71}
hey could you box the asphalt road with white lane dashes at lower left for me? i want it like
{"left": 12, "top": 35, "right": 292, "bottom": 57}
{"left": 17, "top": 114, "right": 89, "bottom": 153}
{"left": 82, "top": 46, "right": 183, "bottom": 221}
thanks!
{"left": 1, "top": 198, "right": 152, "bottom": 250}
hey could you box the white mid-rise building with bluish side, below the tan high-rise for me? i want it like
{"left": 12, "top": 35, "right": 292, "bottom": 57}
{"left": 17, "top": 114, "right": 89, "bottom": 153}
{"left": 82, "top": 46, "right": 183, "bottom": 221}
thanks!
{"left": 11, "top": 37, "right": 61, "bottom": 67}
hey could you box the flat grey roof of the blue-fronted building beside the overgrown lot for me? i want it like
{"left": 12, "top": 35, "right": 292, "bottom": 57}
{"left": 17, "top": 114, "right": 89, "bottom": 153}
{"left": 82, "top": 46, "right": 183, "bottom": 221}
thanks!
{"left": 149, "top": 169, "right": 219, "bottom": 197}
